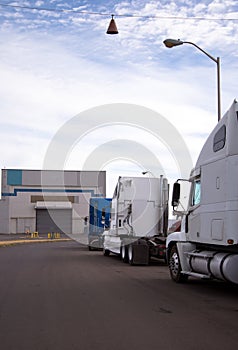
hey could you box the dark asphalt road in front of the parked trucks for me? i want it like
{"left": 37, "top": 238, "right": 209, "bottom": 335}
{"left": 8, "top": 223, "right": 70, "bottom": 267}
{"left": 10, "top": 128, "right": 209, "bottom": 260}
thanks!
{"left": 0, "top": 241, "right": 238, "bottom": 350}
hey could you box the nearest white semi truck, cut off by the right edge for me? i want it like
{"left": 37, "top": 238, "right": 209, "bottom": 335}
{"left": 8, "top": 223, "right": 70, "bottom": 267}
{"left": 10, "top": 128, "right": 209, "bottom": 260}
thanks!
{"left": 166, "top": 101, "right": 238, "bottom": 284}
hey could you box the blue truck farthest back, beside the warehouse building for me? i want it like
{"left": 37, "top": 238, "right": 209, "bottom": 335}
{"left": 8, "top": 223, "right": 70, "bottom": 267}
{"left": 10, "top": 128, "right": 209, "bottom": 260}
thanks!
{"left": 88, "top": 197, "right": 111, "bottom": 250}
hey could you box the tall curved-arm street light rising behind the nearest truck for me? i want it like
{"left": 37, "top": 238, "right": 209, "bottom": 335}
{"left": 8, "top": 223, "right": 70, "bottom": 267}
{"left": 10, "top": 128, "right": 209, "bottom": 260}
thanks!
{"left": 164, "top": 39, "right": 221, "bottom": 121}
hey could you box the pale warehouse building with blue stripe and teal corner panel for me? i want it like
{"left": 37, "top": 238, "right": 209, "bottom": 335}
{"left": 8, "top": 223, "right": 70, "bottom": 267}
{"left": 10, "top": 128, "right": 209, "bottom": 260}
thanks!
{"left": 0, "top": 169, "right": 106, "bottom": 234}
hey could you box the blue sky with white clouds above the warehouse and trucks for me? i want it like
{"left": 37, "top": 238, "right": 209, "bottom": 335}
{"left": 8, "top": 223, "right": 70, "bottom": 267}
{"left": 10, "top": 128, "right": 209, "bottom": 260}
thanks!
{"left": 0, "top": 0, "right": 238, "bottom": 197}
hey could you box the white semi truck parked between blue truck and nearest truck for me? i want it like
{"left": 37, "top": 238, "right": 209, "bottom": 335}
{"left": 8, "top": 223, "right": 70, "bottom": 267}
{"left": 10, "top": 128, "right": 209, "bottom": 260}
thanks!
{"left": 103, "top": 176, "right": 168, "bottom": 265}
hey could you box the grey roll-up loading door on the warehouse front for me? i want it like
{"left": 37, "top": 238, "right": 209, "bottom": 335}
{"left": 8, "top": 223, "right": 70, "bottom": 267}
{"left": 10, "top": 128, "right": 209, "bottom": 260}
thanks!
{"left": 36, "top": 208, "right": 72, "bottom": 234}
